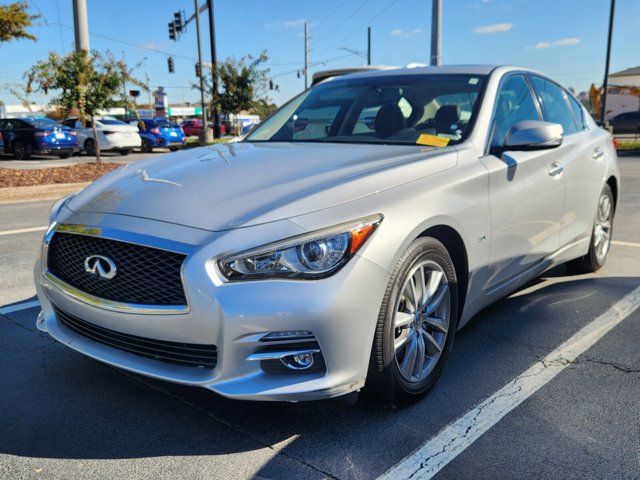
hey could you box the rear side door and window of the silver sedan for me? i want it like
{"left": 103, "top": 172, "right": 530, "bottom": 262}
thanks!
{"left": 531, "top": 75, "right": 610, "bottom": 247}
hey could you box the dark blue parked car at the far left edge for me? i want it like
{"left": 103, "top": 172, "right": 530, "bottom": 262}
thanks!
{"left": 0, "top": 117, "right": 79, "bottom": 160}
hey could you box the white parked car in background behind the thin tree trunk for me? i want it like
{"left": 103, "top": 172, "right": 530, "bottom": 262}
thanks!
{"left": 64, "top": 117, "right": 142, "bottom": 155}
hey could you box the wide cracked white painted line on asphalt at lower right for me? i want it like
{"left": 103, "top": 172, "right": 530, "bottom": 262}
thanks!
{"left": 380, "top": 287, "right": 640, "bottom": 480}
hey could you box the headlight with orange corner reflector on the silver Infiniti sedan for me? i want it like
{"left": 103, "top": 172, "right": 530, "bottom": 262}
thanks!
{"left": 218, "top": 215, "right": 382, "bottom": 280}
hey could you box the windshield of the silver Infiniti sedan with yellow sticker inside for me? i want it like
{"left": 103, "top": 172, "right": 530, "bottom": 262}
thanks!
{"left": 245, "top": 73, "right": 486, "bottom": 147}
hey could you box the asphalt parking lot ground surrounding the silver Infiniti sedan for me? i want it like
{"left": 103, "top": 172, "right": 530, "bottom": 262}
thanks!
{"left": 0, "top": 154, "right": 640, "bottom": 479}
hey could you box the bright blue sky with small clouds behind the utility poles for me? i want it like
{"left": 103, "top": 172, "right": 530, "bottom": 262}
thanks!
{"left": 0, "top": 0, "right": 640, "bottom": 104}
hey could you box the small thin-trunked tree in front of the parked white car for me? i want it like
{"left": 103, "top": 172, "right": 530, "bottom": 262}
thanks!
{"left": 30, "top": 50, "right": 142, "bottom": 162}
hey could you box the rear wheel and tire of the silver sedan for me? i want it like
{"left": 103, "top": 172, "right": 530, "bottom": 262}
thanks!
{"left": 567, "top": 185, "right": 615, "bottom": 273}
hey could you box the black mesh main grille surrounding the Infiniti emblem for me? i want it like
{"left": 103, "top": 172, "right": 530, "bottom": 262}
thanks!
{"left": 47, "top": 232, "right": 187, "bottom": 305}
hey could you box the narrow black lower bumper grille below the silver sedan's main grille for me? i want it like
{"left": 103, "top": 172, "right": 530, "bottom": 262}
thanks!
{"left": 54, "top": 307, "right": 218, "bottom": 369}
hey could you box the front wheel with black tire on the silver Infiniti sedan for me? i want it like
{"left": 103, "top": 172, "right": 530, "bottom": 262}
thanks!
{"left": 365, "top": 237, "right": 458, "bottom": 405}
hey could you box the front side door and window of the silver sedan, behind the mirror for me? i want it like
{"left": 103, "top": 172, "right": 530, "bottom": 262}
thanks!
{"left": 481, "top": 74, "right": 564, "bottom": 290}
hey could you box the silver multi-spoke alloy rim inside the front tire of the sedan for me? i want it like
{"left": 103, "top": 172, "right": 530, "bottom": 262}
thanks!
{"left": 394, "top": 260, "right": 451, "bottom": 383}
